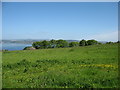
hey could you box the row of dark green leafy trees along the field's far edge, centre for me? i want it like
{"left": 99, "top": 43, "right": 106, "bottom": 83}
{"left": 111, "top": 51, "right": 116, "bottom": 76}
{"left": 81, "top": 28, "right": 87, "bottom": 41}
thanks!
{"left": 32, "top": 39, "right": 100, "bottom": 49}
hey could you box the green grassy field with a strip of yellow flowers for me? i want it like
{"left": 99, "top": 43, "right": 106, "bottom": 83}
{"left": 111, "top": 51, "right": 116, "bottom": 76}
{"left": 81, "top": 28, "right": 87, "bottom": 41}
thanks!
{"left": 2, "top": 44, "right": 118, "bottom": 88}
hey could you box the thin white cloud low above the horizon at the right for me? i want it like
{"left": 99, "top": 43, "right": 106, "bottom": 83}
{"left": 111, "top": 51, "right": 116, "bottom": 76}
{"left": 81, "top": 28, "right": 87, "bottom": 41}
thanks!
{"left": 90, "top": 31, "right": 120, "bottom": 42}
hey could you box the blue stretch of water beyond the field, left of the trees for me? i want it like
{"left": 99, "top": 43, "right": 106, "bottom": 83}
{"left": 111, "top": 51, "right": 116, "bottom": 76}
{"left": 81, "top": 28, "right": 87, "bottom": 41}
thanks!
{"left": 0, "top": 43, "right": 32, "bottom": 51}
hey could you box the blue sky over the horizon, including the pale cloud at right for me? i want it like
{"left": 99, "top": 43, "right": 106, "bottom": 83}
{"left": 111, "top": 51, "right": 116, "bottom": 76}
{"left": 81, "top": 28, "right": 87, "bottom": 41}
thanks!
{"left": 2, "top": 2, "right": 118, "bottom": 41}
